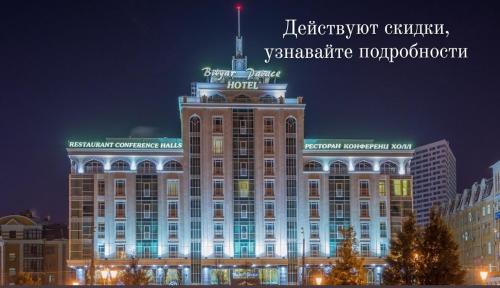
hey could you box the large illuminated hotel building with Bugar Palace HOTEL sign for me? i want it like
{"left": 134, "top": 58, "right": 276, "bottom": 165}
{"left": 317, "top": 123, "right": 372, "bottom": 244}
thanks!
{"left": 67, "top": 12, "right": 413, "bottom": 284}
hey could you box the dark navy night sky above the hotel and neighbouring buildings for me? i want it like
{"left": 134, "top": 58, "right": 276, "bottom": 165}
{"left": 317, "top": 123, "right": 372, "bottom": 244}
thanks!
{"left": 0, "top": 0, "right": 500, "bottom": 222}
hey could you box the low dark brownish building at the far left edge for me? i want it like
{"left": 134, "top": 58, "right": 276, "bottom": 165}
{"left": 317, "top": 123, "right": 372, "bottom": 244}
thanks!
{"left": 0, "top": 215, "right": 68, "bottom": 285}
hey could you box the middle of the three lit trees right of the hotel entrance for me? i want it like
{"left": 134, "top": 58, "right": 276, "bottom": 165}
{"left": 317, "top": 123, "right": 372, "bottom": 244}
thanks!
{"left": 383, "top": 213, "right": 421, "bottom": 285}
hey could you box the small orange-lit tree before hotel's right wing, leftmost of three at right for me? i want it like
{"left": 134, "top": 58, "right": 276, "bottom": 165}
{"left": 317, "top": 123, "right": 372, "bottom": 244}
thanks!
{"left": 328, "top": 227, "right": 366, "bottom": 285}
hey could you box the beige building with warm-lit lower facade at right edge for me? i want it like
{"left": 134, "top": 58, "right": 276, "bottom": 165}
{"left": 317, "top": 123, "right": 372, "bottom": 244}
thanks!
{"left": 443, "top": 164, "right": 498, "bottom": 284}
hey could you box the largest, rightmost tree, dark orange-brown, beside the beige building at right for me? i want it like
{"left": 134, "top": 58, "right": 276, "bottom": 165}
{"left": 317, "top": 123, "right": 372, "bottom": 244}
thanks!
{"left": 418, "top": 209, "right": 465, "bottom": 285}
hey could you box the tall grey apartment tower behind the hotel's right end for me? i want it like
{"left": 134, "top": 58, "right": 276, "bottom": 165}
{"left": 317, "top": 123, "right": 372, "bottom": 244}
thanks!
{"left": 411, "top": 140, "right": 457, "bottom": 225}
